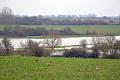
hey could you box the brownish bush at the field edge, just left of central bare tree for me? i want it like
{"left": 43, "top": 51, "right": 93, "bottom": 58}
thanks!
{"left": 17, "top": 40, "right": 51, "bottom": 57}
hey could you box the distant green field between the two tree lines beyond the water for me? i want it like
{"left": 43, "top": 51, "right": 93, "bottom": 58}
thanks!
{"left": 0, "top": 25, "right": 120, "bottom": 34}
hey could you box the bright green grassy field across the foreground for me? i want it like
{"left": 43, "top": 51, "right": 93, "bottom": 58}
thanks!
{"left": 0, "top": 56, "right": 120, "bottom": 80}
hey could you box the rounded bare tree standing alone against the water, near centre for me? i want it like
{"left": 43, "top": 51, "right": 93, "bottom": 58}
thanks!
{"left": 44, "top": 30, "right": 61, "bottom": 50}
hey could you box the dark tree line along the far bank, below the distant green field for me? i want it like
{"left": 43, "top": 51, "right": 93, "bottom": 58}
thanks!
{"left": 0, "top": 25, "right": 79, "bottom": 37}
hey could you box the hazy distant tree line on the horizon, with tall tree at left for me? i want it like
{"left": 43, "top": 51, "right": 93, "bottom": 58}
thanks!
{"left": 0, "top": 8, "right": 120, "bottom": 25}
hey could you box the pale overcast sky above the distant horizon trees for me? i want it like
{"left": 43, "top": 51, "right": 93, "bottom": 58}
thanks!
{"left": 0, "top": 0, "right": 120, "bottom": 16}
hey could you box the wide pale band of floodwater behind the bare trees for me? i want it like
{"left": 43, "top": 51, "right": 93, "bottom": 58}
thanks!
{"left": 0, "top": 36, "right": 120, "bottom": 48}
